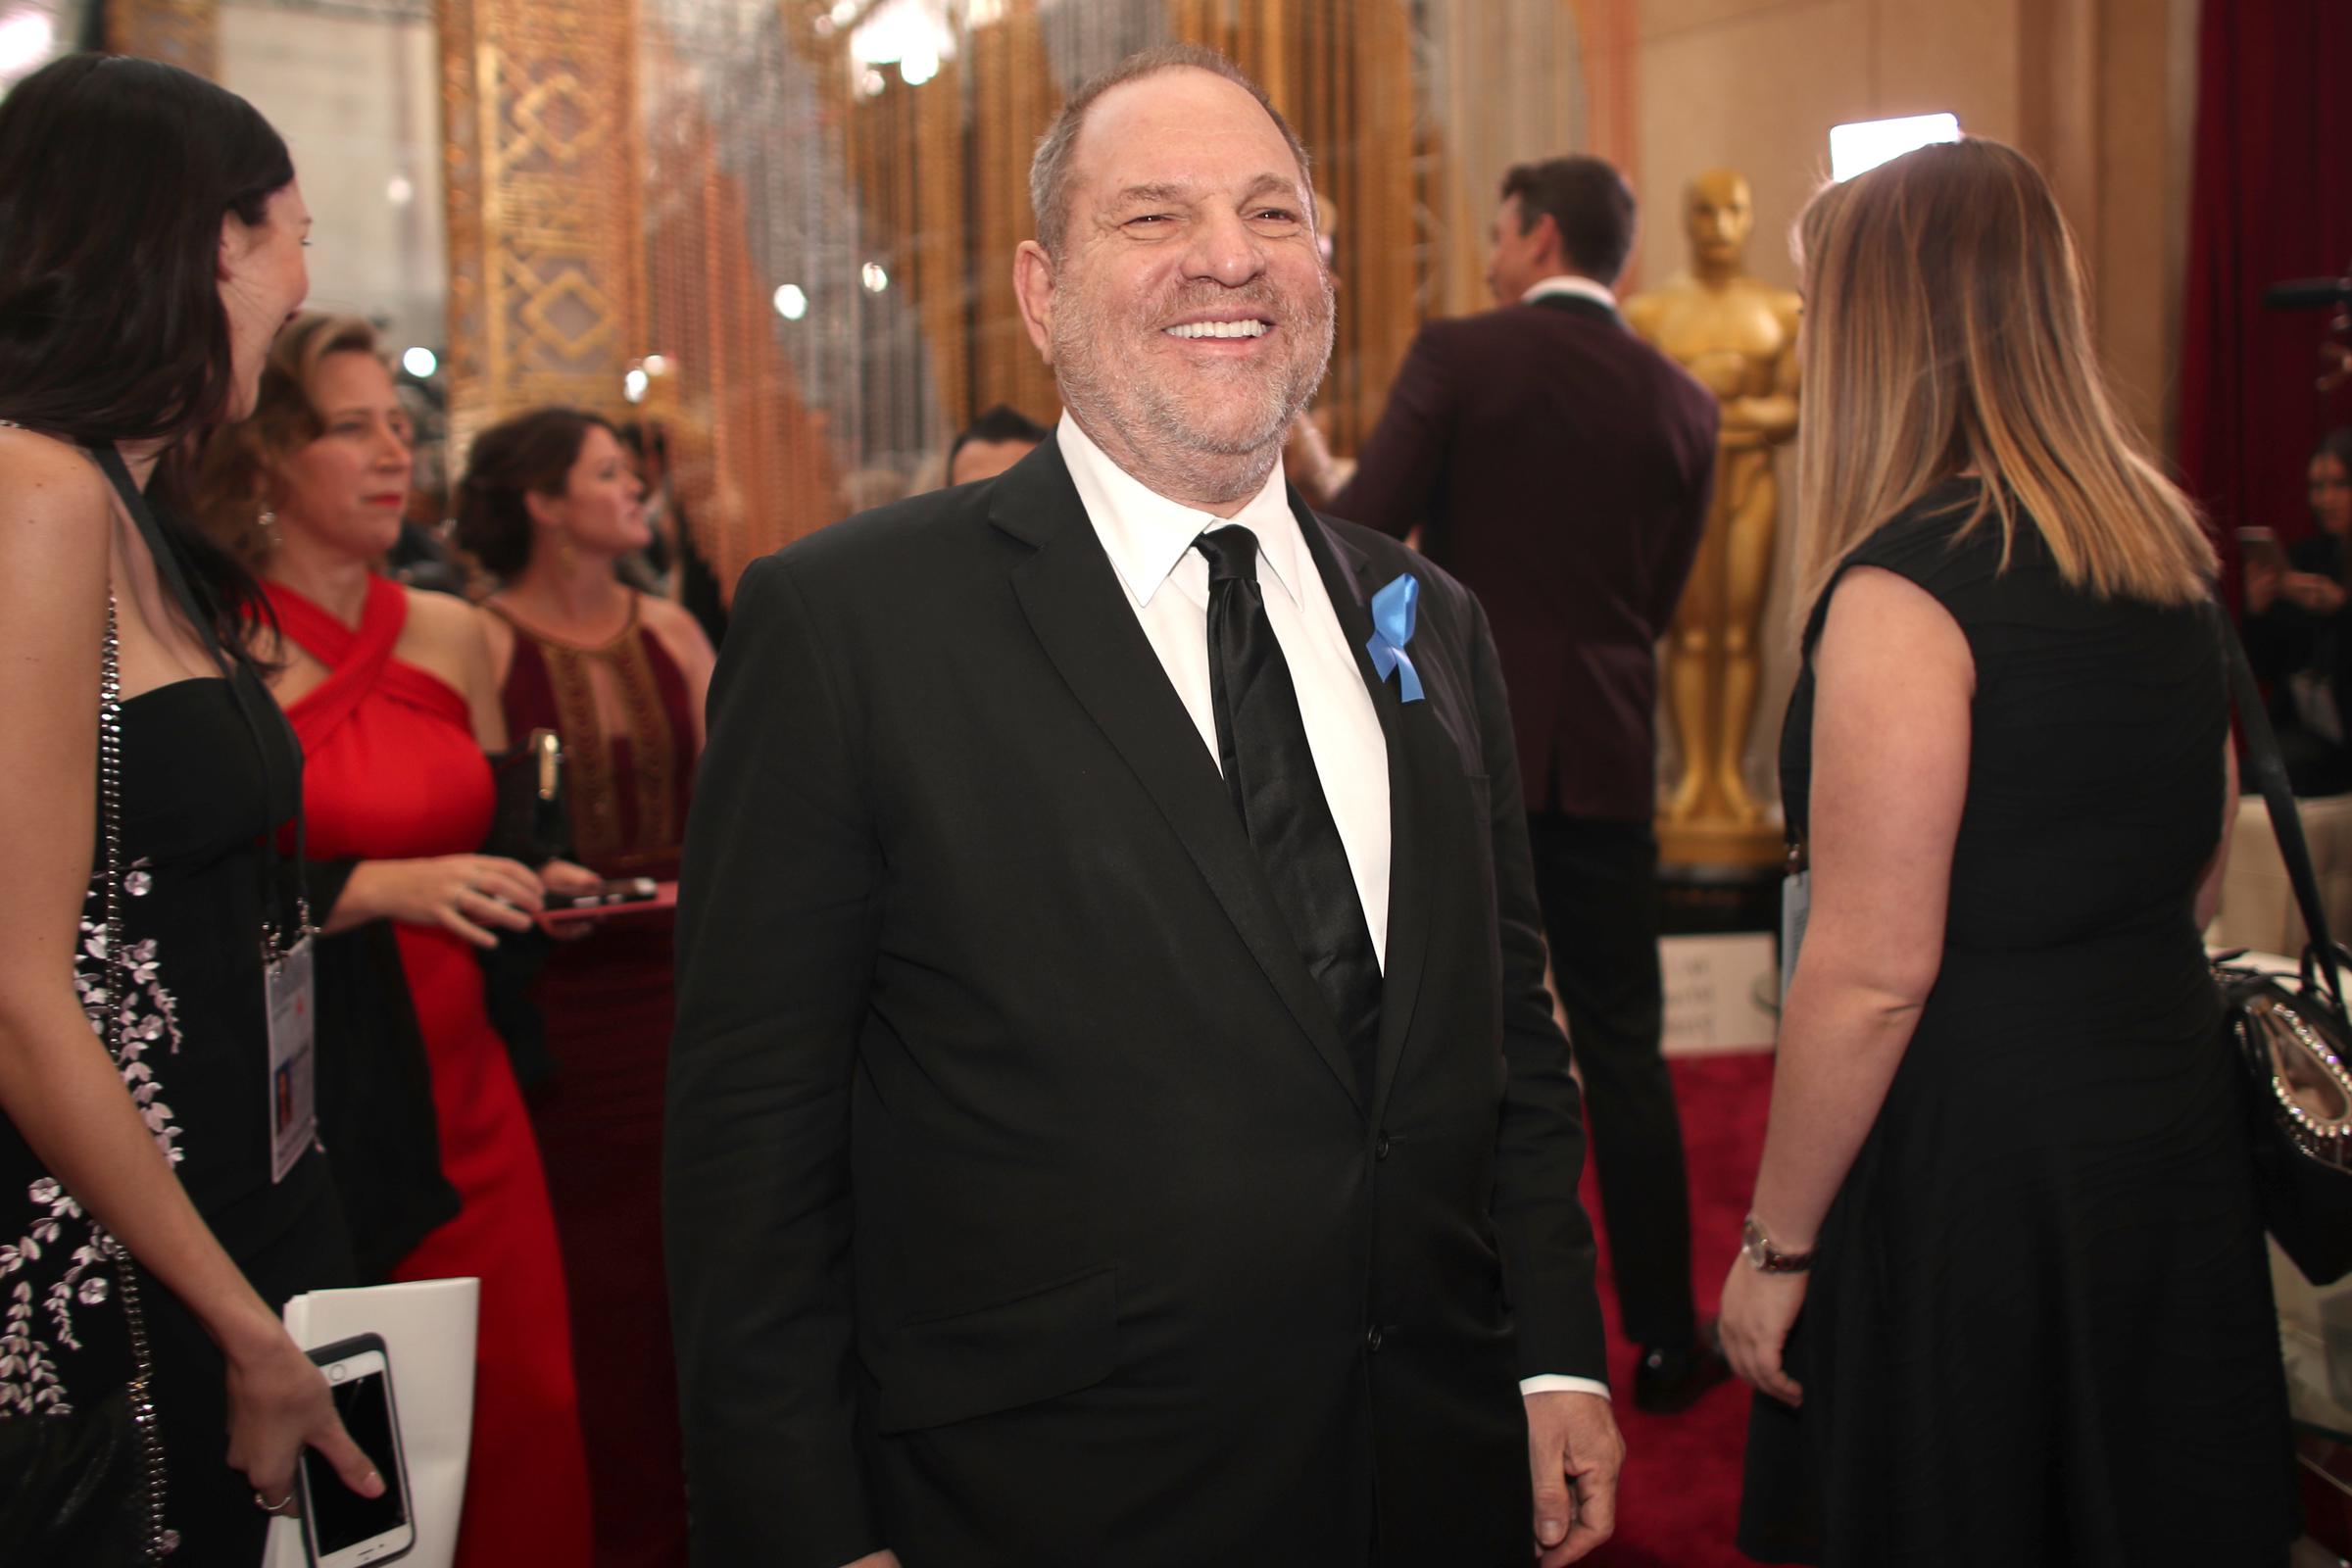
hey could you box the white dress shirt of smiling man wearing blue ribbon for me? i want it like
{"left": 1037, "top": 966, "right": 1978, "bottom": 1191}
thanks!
{"left": 1054, "top": 416, "right": 1609, "bottom": 1396}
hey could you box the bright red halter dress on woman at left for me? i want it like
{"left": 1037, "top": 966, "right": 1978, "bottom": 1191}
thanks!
{"left": 269, "top": 578, "right": 590, "bottom": 1568}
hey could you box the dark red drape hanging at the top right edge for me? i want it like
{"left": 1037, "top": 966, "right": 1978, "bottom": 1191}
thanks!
{"left": 2180, "top": 0, "right": 2352, "bottom": 585}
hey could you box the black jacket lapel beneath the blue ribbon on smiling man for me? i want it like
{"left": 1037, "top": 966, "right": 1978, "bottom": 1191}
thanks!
{"left": 1292, "top": 503, "right": 1445, "bottom": 1121}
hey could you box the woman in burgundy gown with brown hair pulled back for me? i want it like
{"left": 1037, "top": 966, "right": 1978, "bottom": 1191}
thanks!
{"left": 459, "top": 409, "right": 712, "bottom": 1568}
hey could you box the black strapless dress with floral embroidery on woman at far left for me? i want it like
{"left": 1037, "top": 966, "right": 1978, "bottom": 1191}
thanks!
{"left": 0, "top": 674, "right": 353, "bottom": 1568}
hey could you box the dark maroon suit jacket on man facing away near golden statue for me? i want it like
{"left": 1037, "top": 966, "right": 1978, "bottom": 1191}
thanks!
{"left": 1331, "top": 296, "right": 1719, "bottom": 823}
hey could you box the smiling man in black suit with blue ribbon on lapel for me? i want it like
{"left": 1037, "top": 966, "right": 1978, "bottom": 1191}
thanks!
{"left": 665, "top": 49, "right": 1623, "bottom": 1568}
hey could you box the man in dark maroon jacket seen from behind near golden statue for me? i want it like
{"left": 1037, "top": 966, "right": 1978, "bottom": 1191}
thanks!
{"left": 1310, "top": 158, "right": 1727, "bottom": 1410}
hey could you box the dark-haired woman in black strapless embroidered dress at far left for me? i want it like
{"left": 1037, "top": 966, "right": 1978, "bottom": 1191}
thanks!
{"left": 0, "top": 54, "right": 381, "bottom": 1568}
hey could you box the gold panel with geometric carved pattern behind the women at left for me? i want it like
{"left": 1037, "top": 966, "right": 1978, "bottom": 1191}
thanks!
{"left": 437, "top": 0, "right": 642, "bottom": 461}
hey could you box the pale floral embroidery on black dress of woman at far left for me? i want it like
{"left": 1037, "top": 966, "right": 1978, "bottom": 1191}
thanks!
{"left": 0, "top": 860, "right": 181, "bottom": 1415}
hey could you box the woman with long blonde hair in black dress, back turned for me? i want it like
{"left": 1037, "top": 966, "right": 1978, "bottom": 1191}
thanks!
{"left": 1722, "top": 141, "right": 2295, "bottom": 1568}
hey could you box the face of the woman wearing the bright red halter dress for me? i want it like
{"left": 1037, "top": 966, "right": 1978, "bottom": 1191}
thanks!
{"left": 269, "top": 353, "right": 412, "bottom": 560}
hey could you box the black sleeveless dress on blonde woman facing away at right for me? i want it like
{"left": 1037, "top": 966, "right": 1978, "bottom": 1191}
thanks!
{"left": 1740, "top": 482, "right": 2295, "bottom": 1568}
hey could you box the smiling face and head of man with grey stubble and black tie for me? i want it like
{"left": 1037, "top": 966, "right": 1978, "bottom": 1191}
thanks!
{"left": 1016, "top": 69, "right": 1331, "bottom": 499}
